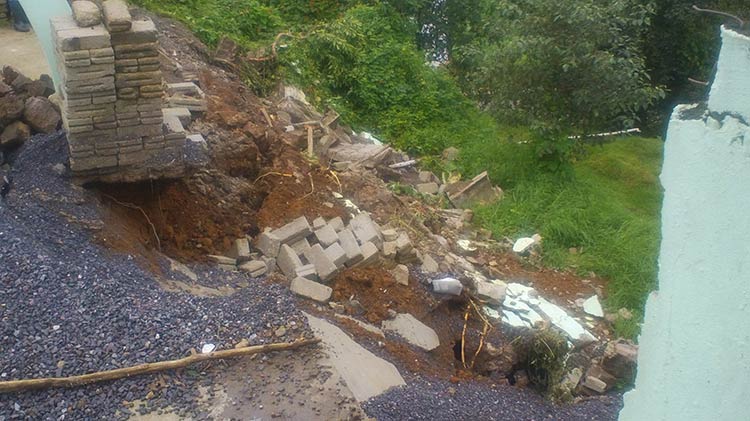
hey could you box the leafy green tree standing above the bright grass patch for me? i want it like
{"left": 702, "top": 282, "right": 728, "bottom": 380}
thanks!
{"left": 448, "top": 0, "right": 662, "bottom": 159}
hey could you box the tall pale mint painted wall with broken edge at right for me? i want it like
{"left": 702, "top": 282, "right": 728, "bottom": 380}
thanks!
{"left": 620, "top": 29, "right": 750, "bottom": 421}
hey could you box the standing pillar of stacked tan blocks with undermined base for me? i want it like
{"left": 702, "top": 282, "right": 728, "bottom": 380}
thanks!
{"left": 51, "top": 0, "right": 186, "bottom": 181}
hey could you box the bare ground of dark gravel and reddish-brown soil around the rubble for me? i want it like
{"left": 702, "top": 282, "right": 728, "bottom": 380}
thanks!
{"left": 0, "top": 8, "right": 621, "bottom": 420}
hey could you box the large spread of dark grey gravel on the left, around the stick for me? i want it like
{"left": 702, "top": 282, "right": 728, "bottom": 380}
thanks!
{"left": 0, "top": 134, "right": 307, "bottom": 420}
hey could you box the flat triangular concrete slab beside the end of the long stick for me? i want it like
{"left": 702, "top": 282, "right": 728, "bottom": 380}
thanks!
{"left": 303, "top": 313, "right": 406, "bottom": 402}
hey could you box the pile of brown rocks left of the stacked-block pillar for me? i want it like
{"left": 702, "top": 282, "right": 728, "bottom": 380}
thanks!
{"left": 0, "top": 66, "right": 60, "bottom": 155}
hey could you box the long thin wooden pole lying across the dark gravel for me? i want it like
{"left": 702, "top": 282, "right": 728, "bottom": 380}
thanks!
{"left": 0, "top": 339, "right": 320, "bottom": 393}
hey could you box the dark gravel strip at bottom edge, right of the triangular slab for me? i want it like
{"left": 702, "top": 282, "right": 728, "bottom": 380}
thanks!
{"left": 362, "top": 379, "right": 621, "bottom": 421}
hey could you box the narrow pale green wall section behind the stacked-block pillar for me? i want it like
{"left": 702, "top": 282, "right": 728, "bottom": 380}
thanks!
{"left": 20, "top": 0, "right": 73, "bottom": 91}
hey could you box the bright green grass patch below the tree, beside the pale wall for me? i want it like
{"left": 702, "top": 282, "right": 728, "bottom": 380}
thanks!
{"left": 460, "top": 130, "right": 662, "bottom": 337}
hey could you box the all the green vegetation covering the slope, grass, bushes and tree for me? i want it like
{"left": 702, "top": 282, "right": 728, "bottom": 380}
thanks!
{"left": 135, "top": 0, "right": 676, "bottom": 336}
